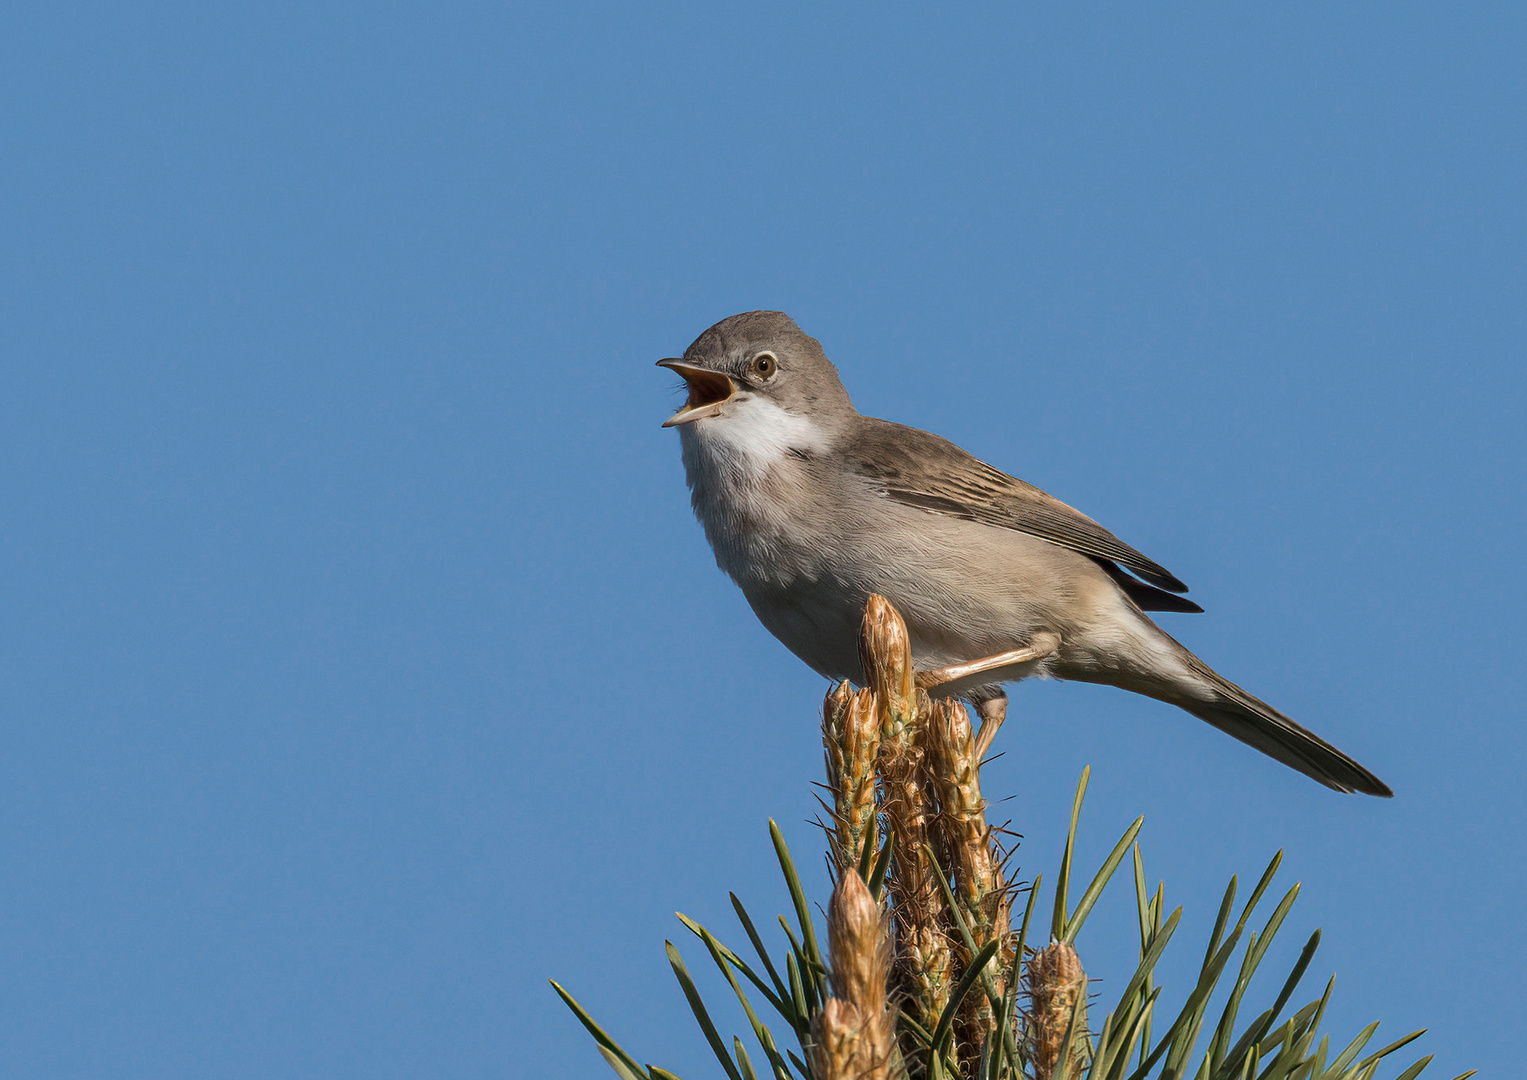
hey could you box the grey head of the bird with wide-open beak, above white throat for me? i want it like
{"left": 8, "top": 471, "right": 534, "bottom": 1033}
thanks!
{"left": 658, "top": 312, "right": 858, "bottom": 432}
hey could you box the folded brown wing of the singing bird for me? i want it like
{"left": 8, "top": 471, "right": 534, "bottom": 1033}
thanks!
{"left": 847, "top": 417, "right": 1188, "bottom": 593}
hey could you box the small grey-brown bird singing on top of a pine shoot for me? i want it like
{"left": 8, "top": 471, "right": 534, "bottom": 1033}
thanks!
{"left": 658, "top": 312, "right": 1393, "bottom": 796}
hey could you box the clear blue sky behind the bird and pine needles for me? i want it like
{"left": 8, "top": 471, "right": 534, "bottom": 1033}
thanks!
{"left": 0, "top": 0, "right": 1527, "bottom": 1080}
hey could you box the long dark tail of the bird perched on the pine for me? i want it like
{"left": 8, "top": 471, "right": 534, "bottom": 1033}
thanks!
{"left": 1145, "top": 646, "right": 1394, "bottom": 799}
